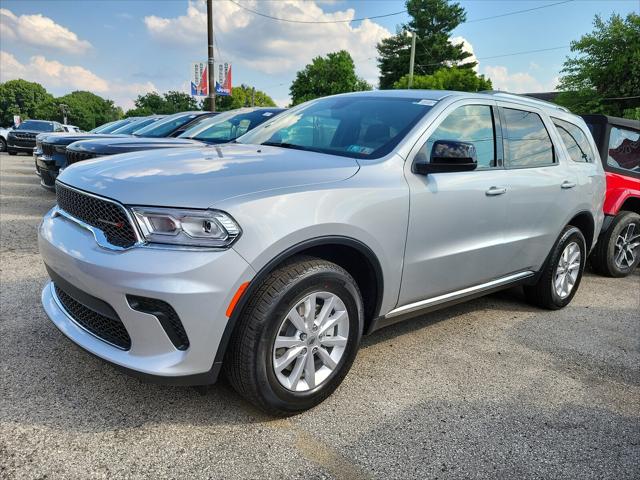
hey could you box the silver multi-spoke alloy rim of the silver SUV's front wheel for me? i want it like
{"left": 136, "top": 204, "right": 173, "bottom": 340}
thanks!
{"left": 272, "top": 292, "right": 349, "bottom": 392}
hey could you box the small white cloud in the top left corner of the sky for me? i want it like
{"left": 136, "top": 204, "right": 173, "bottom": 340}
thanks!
{"left": 0, "top": 8, "right": 91, "bottom": 53}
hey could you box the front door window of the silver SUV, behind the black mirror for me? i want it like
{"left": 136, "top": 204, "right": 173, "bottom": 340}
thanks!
{"left": 417, "top": 105, "right": 496, "bottom": 168}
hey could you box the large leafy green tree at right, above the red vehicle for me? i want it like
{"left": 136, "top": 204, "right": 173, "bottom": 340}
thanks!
{"left": 555, "top": 13, "right": 640, "bottom": 118}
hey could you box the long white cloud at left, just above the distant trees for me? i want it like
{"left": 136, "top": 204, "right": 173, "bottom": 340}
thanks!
{"left": 0, "top": 51, "right": 157, "bottom": 109}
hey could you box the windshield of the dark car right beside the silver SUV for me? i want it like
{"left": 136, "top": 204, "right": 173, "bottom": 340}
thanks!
{"left": 180, "top": 109, "right": 282, "bottom": 143}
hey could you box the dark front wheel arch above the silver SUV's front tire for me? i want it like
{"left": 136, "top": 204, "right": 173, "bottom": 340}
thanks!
{"left": 214, "top": 236, "right": 384, "bottom": 363}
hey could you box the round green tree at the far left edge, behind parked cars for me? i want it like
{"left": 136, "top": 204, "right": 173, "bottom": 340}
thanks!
{"left": 0, "top": 79, "right": 53, "bottom": 125}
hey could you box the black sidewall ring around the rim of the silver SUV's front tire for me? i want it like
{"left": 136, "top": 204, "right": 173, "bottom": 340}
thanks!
{"left": 256, "top": 270, "right": 363, "bottom": 412}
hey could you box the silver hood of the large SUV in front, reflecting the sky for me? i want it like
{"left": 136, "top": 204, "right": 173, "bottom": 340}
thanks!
{"left": 58, "top": 144, "right": 359, "bottom": 208}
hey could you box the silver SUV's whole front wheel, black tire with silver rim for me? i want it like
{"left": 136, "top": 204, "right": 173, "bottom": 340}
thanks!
{"left": 224, "top": 256, "right": 364, "bottom": 416}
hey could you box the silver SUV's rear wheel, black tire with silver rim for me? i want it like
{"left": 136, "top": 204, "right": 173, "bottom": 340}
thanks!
{"left": 524, "top": 225, "right": 587, "bottom": 310}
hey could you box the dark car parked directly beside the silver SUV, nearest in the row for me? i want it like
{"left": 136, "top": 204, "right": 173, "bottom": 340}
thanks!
{"left": 66, "top": 108, "right": 284, "bottom": 165}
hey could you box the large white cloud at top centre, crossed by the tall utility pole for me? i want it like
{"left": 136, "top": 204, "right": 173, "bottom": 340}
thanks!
{"left": 144, "top": 0, "right": 391, "bottom": 84}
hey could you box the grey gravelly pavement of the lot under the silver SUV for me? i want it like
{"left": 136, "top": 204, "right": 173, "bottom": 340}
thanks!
{"left": 0, "top": 154, "right": 640, "bottom": 479}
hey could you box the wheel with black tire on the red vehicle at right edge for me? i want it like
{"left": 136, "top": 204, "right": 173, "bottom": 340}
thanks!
{"left": 590, "top": 211, "right": 640, "bottom": 277}
